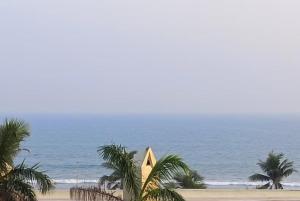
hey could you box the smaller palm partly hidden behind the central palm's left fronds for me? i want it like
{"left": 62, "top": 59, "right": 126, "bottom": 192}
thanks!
{"left": 99, "top": 151, "right": 137, "bottom": 190}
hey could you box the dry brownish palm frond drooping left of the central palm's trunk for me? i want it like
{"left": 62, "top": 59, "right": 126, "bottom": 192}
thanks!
{"left": 70, "top": 187, "right": 123, "bottom": 201}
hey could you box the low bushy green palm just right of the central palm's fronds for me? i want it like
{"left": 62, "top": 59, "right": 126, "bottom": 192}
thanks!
{"left": 170, "top": 170, "right": 206, "bottom": 189}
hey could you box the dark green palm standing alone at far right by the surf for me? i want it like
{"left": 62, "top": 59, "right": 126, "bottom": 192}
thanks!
{"left": 249, "top": 151, "right": 296, "bottom": 189}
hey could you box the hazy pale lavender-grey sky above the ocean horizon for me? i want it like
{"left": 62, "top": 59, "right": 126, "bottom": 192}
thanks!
{"left": 0, "top": 0, "right": 300, "bottom": 113}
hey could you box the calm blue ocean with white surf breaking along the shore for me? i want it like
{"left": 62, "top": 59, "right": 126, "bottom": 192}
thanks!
{"left": 1, "top": 114, "right": 300, "bottom": 189}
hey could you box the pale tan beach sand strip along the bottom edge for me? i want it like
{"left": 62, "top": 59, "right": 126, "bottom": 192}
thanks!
{"left": 38, "top": 189, "right": 300, "bottom": 201}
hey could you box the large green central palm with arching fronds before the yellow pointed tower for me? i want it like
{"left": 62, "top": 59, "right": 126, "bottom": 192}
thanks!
{"left": 98, "top": 144, "right": 189, "bottom": 201}
